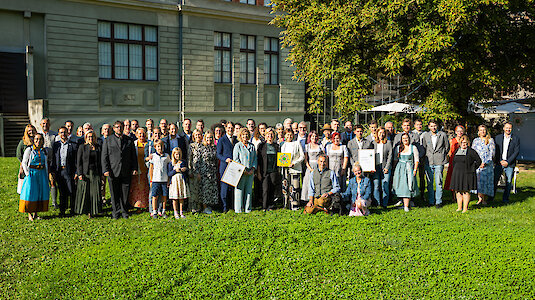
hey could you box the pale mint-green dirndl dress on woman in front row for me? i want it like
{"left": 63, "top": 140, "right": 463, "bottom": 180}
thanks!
{"left": 393, "top": 145, "right": 420, "bottom": 198}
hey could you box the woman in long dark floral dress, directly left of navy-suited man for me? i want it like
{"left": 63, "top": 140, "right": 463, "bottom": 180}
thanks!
{"left": 199, "top": 130, "right": 219, "bottom": 214}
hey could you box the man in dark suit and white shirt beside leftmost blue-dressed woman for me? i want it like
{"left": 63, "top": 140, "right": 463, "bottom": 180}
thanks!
{"left": 50, "top": 126, "right": 77, "bottom": 216}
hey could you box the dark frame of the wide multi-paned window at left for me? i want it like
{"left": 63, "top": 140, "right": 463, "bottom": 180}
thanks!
{"left": 97, "top": 20, "right": 159, "bottom": 81}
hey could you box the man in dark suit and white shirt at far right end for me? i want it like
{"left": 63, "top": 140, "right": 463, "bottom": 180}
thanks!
{"left": 489, "top": 122, "right": 520, "bottom": 203}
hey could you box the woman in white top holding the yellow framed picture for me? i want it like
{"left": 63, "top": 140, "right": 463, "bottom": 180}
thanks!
{"left": 281, "top": 130, "right": 305, "bottom": 210}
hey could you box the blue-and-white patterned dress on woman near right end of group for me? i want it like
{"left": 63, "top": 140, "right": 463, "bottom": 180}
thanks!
{"left": 472, "top": 138, "right": 496, "bottom": 197}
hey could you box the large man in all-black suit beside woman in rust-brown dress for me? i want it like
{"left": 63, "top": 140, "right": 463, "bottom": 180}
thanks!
{"left": 102, "top": 121, "right": 138, "bottom": 219}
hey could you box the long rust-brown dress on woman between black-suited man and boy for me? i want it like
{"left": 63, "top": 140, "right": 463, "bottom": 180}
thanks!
{"left": 128, "top": 140, "right": 149, "bottom": 208}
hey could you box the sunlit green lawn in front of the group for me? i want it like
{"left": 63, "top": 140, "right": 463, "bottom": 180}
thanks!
{"left": 0, "top": 158, "right": 535, "bottom": 299}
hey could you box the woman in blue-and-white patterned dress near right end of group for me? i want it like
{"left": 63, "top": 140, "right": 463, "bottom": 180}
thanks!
{"left": 472, "top": 125, "right": 496, "bottom": 205}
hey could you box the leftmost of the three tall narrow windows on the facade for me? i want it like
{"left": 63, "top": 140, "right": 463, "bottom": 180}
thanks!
{"left": 214, "top": 32, "right": 231, "bottom": 83}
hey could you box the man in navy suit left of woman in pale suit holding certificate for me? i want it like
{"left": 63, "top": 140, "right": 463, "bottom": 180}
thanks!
{"left": 217, "top": 121, "right": 237, "bottom": 212}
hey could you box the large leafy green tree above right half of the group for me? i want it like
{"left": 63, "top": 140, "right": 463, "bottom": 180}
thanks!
{"left": 272, "top": 0, "right": 535, "bottom": 121}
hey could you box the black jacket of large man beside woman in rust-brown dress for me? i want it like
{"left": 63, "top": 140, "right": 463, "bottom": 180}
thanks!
{"left": 101, "top": 134, "right": 138, "bottom": 178}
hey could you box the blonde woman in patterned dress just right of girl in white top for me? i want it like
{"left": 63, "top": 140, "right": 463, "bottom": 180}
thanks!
{"left": 188, "top": 129, "right": 203, "bottom": 214}
